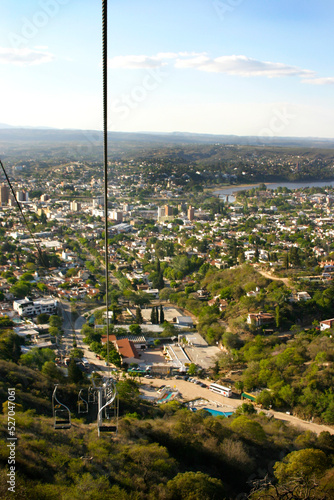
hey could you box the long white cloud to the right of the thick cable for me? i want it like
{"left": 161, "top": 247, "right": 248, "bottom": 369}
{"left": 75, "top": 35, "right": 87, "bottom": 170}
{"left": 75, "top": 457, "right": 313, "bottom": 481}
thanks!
{"left": 175, "top": 55, "right": 315, "bottom": 78}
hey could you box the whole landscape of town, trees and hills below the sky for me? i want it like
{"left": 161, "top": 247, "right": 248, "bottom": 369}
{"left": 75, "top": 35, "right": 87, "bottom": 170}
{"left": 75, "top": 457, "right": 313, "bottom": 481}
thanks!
{"left": 0, "top": 135, "right": 334, "bottom": 500}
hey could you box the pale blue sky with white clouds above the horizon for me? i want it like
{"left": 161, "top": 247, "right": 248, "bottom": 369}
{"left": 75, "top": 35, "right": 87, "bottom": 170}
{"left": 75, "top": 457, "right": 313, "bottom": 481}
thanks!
{"left": 0, "top": 0, "right": 334, "bottom": 138}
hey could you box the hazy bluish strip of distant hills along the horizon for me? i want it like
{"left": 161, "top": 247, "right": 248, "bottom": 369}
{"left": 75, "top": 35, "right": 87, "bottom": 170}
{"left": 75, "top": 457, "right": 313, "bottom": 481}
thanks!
{"left": 0, "top": 124, "right": 334, "bottom": 148}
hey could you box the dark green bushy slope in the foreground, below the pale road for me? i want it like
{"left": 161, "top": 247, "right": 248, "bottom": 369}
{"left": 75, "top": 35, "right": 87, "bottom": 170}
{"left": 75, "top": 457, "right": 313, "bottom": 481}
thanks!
{"left": 0, "top": 361, "right": 334, "bottom": 500}
